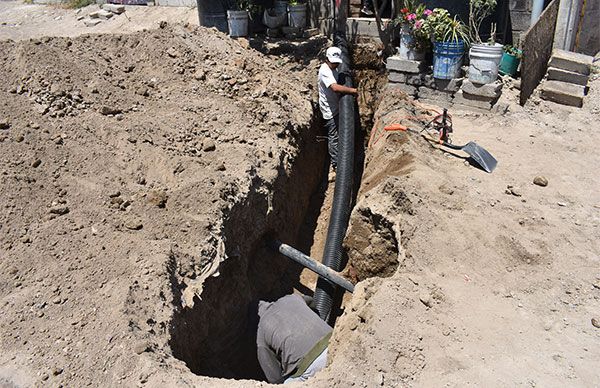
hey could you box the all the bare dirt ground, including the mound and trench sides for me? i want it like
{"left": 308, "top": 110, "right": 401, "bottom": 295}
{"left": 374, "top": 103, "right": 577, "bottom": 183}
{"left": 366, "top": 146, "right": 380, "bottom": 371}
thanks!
{"left": 0, "top": 2, "right": 600, "bottom": 387}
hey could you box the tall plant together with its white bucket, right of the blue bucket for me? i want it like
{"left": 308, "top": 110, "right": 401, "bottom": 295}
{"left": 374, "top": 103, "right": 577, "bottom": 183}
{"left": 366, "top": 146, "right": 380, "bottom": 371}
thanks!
{"left": 469, "top": 0, "right": 502, "bottom": 84}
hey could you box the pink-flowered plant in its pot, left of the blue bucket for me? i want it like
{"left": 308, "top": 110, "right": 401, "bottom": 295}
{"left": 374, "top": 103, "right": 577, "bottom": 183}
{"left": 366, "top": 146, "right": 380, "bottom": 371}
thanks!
{"left": 394, "top": 0, "right": 433, "bottom": 61}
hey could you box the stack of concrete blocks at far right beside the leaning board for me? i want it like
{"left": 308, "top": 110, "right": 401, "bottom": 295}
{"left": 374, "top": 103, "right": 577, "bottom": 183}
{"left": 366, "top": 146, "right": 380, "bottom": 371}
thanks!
{"left": 541, "top": 50, "right": 594, "bottom": 108}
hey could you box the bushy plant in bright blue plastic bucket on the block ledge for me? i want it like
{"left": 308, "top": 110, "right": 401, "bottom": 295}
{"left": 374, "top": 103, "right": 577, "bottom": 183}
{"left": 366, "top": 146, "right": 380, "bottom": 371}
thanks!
{"left": 423, "top": 8, "right": 469, "bottom": 79}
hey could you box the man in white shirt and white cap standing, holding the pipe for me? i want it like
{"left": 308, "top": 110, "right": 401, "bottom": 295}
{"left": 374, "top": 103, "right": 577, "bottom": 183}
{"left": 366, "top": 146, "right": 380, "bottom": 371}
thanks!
{"left": 318, "top": 47, "right": 358, "bottom": 181}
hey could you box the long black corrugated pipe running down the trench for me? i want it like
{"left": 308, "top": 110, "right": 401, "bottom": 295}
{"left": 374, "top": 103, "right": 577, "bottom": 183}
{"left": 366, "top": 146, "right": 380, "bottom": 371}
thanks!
{"left": 314, "top": 30, "right": 356, "bottom": 321}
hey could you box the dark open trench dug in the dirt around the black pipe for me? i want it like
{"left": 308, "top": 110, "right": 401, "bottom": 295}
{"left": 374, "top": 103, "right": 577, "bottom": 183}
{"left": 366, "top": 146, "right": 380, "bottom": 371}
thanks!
{"left": 169, "top": 40, "right": 392, "bottom": 380}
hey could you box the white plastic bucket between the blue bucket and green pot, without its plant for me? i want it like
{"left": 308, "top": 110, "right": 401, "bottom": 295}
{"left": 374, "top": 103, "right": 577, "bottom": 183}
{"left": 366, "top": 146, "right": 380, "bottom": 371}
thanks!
{"left": 469, "top": 43, "right": 502, "bottom": 84}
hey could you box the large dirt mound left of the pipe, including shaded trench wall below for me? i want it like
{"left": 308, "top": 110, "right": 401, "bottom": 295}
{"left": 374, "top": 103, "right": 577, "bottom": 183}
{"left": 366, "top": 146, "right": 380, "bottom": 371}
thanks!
{"left": 0, "top": 25, "right": 325, "bottom": 386}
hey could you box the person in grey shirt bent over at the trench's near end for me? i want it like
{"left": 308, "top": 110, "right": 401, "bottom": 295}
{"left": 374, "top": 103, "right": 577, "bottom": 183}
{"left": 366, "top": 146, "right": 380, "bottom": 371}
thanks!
{"left": 256, "top": 294, "right": 333, "bottom": 384}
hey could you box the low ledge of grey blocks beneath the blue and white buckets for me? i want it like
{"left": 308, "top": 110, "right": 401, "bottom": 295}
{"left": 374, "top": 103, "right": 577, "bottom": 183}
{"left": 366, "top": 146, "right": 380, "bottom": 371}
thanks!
{"left": 387, "top": 56, "right": 502, "bottom": 110}
